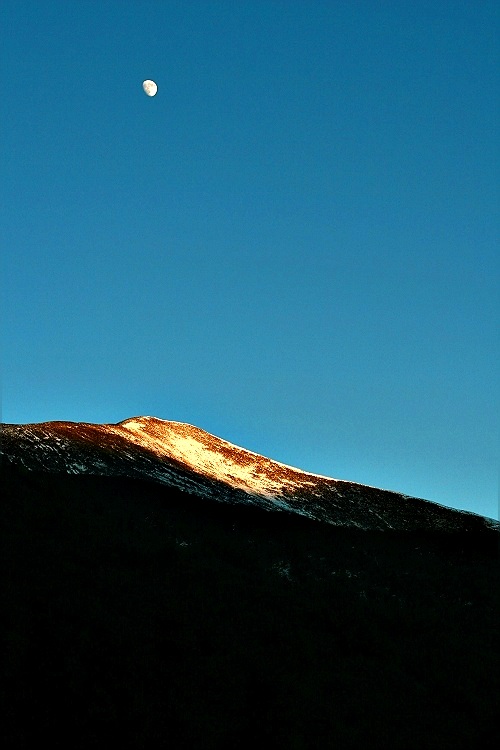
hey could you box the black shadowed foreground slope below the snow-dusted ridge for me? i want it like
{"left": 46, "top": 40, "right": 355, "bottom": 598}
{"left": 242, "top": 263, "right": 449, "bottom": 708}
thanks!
{"left": 0, "top": 463, "right": 500, "bottom": 750}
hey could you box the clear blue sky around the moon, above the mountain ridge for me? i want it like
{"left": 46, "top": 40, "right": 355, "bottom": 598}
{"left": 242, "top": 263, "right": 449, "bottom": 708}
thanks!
{"left": 0, "top": 0, "right": 500, "bottom": 517}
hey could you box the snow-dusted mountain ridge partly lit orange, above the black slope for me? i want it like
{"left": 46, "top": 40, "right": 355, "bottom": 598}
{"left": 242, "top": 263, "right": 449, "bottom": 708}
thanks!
{"left": 1, "top": 417, "right": 500, "bottom": 531}
